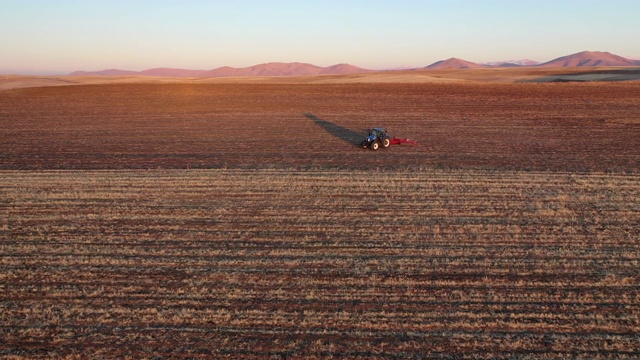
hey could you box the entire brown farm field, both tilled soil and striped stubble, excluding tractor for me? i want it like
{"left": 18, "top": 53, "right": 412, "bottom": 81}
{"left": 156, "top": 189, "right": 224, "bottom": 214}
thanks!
{"left": 0, "top": 83, "right": 640, "bottom": 359}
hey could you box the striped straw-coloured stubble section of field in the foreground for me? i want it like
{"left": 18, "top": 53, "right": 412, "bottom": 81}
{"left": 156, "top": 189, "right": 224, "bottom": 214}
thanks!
{"left": 0, "top": 169, "right": 640, "bottom": 358}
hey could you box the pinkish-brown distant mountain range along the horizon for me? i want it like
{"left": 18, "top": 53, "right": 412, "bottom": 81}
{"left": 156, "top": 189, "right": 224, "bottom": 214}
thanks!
{"left": 69, "top": 51, "right": 640, "bottom": 78}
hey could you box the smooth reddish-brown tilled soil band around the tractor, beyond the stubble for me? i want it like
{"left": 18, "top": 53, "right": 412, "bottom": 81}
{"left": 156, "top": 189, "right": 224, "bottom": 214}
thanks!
{"left": 0, "top": 83, "right": 640, "bottom": 172}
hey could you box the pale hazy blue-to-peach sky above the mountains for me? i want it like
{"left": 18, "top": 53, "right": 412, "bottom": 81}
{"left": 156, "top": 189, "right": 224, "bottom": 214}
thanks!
{"left": 0, "top": 0, "right": 640, "bottom": 74}
